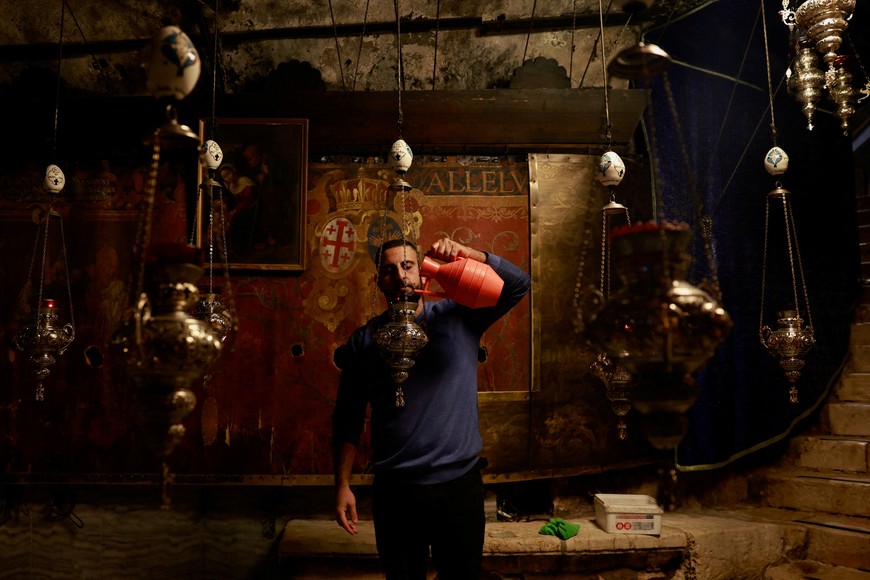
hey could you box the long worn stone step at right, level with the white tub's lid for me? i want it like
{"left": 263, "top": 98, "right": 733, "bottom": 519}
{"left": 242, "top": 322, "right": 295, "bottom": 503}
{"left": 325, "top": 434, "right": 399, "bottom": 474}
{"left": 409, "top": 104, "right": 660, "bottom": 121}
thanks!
{"left": 748, "top": 468, "right": 870, "bottom": 518}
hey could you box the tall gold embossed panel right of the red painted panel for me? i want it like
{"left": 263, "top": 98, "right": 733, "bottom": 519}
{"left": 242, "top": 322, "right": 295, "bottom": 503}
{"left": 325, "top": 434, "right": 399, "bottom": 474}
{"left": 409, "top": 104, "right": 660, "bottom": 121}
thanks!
{"left": 529, "top": 154, "right": 648, "bottom": 469}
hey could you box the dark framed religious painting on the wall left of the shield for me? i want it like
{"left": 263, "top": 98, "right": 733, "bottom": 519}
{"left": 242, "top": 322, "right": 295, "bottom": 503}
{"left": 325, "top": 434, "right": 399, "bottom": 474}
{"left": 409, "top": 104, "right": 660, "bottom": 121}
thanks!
{"left": 197, "top": 118, "right": 308, "bottom": 271}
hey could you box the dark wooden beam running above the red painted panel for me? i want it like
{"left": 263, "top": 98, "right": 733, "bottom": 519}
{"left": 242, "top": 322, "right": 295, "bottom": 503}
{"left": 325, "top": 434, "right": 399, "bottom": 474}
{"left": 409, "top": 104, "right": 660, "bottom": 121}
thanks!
{"left": 217, "top": 89, "right": 647, "bottom": 155}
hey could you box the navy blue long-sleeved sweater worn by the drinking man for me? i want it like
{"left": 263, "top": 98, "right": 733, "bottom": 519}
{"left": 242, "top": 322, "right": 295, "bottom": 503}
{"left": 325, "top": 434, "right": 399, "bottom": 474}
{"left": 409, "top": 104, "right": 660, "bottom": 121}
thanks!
{"left": 332, "top": 254, "right": 531, "bottom": 484}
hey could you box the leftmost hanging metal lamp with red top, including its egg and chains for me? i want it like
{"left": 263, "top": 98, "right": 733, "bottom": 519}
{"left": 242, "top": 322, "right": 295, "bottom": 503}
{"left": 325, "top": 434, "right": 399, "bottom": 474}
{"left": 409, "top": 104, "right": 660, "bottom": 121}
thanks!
{"left": 15, "top": 165, "right": 76, "bottom": 401}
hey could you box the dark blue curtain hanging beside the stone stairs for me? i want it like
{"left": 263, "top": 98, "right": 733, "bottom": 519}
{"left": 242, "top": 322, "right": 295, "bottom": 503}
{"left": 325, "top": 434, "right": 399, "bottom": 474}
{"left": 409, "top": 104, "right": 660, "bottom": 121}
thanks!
{"left": 638, "top": 0, "right": 860, "bottom": 471}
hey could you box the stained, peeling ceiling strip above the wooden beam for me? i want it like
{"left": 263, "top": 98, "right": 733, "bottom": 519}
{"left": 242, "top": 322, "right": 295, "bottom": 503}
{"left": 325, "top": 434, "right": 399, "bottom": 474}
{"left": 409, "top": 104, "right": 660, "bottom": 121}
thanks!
{"left": 0, "top": 0, "right": 870, "bottom": 152}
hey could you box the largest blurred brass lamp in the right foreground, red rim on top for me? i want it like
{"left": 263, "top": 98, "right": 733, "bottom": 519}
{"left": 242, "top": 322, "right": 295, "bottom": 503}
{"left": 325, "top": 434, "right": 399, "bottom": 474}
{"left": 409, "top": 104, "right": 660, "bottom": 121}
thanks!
{"left": 586, "top": 222, "right": 732, "bottom": 449}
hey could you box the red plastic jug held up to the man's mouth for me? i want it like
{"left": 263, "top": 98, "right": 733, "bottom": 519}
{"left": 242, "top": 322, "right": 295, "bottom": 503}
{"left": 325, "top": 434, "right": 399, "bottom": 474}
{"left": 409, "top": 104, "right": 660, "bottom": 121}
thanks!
{"left": 416, "top": 256, "right": 504, "bottom": 308}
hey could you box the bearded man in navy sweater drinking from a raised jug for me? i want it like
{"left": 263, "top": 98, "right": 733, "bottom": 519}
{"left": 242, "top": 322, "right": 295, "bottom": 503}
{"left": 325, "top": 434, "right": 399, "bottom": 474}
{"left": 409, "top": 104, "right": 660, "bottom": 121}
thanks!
{"left": 333, "top": 238, "right": 531, "bottom": 580}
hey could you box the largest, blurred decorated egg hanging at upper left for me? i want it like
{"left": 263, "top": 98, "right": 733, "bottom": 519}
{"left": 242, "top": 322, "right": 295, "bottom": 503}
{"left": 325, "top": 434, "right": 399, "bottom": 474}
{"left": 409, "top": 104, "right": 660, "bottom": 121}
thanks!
{"left": 145, "top": 26, "right": 202, "bottom": 100}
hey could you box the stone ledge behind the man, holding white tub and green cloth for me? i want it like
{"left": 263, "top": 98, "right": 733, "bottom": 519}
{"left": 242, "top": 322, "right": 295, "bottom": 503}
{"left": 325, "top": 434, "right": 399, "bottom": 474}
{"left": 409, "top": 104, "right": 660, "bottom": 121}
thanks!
{"left": 278, "top": 507, "right": 844, "bottom": 580}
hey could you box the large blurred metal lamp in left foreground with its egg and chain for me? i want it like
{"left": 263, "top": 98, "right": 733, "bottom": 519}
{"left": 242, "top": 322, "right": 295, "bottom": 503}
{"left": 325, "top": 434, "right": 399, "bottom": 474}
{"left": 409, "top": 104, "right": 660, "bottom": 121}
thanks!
{"left": 111, "top": 26, "right": 221, "bottom": 509}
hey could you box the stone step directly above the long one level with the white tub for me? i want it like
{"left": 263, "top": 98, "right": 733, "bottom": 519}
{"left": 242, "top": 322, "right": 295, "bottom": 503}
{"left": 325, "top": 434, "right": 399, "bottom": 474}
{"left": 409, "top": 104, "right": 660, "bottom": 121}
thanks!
{"left": 785, "top": 435, "right": 870, "bottom": 473}
